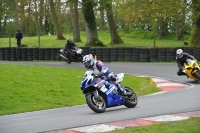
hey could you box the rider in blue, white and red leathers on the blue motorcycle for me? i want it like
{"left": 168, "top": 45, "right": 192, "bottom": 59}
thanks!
{"left": 83, "top": 54, "right": 131, "bottom": 96}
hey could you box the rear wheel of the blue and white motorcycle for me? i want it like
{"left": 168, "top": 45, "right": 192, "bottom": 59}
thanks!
{"left": 124, "top": 86, "right": 138, "bottom": 108}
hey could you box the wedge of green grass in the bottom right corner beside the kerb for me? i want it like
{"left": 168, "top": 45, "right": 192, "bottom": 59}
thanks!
{"left": 107, "top": 118, "right": 200, "bottom": 133}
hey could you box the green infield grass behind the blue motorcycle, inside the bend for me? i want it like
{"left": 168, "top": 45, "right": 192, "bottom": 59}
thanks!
{"left": 0, "top": 64, "right": 160, "bottom": 115}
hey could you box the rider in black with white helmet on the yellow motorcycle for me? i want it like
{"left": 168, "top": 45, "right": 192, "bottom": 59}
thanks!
{"left": 176, "top": 49, "right": 196, "bottom": 77}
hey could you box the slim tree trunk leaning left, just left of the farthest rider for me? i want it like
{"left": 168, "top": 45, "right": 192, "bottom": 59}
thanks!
{"left": 49, "top": 0, "right": 65, "bottom": 40}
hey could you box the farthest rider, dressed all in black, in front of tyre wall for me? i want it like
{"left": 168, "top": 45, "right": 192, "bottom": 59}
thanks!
{"left": 63, "top": 38, "right": 76, "bottom": 59}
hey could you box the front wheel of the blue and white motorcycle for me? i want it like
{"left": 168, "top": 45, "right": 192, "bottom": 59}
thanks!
{"left": 86, "top": 93, "right": 106, "bottom": 113}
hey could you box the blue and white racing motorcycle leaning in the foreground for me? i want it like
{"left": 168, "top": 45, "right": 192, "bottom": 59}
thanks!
{"left": 80, "top": 71, "right": 138, "bottom": 113}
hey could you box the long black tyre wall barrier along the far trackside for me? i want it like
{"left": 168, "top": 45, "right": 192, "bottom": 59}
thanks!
{"left": 0, "top": 47, "right": 200, "bottom": 62}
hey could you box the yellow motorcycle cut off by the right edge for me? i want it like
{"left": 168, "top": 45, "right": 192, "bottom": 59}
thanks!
{"left": 184, "top": 59, "right": 200, "bottom": 81}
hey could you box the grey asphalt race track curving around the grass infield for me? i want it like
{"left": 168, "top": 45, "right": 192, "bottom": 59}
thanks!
{"left": 0, "top": 61, "right": 200, "bottom": 133}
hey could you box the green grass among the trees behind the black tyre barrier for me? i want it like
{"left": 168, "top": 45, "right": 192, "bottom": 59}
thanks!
{"left": 0, "top": 31, "right": 189, "bottom": 48}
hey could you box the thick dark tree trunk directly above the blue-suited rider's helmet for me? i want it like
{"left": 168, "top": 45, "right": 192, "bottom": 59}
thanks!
{"left": 82, "top": 0, "right": 103, "bottom": 46}
